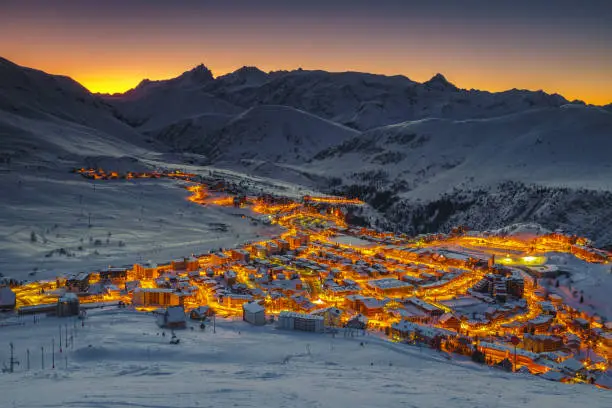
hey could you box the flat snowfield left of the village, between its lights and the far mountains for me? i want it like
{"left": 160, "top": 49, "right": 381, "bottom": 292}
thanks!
{"left": 0, "top": 168, "right": 278, "bottom": 279}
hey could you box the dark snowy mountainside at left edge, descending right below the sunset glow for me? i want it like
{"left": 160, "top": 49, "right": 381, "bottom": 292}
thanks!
{"left": 0, "top": 59, "right": 151, "bottom": 165}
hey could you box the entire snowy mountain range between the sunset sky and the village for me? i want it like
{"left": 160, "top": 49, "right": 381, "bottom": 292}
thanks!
{"left": 0, "top": 59, "right": 612, "bottom": 242}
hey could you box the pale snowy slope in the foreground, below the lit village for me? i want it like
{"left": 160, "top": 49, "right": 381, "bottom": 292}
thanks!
{"left": 0, "top": 310, "right": 610, "bottom": 408}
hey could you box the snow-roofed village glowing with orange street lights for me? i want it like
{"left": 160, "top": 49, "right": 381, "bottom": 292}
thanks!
{"left": 0, "top": 169, "right": 612, "bottom": 388}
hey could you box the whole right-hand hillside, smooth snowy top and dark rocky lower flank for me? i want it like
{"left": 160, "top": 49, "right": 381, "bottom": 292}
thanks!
{"left": 303, "top": 105, "right": 612, "bottom": 244}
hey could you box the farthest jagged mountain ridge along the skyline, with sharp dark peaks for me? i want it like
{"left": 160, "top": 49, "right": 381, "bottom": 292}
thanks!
{"left": 105, "top": 66, "right": 580, "bottom": 130}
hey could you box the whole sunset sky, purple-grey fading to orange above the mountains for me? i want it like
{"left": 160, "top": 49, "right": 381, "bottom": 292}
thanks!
{"left": 0, "top": 0, "right": 612, "bottom": 104}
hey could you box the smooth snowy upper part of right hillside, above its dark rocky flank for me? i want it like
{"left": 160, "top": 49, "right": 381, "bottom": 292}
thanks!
{"left": 312, "top": 105, "right": 612, "bottom": 198}
